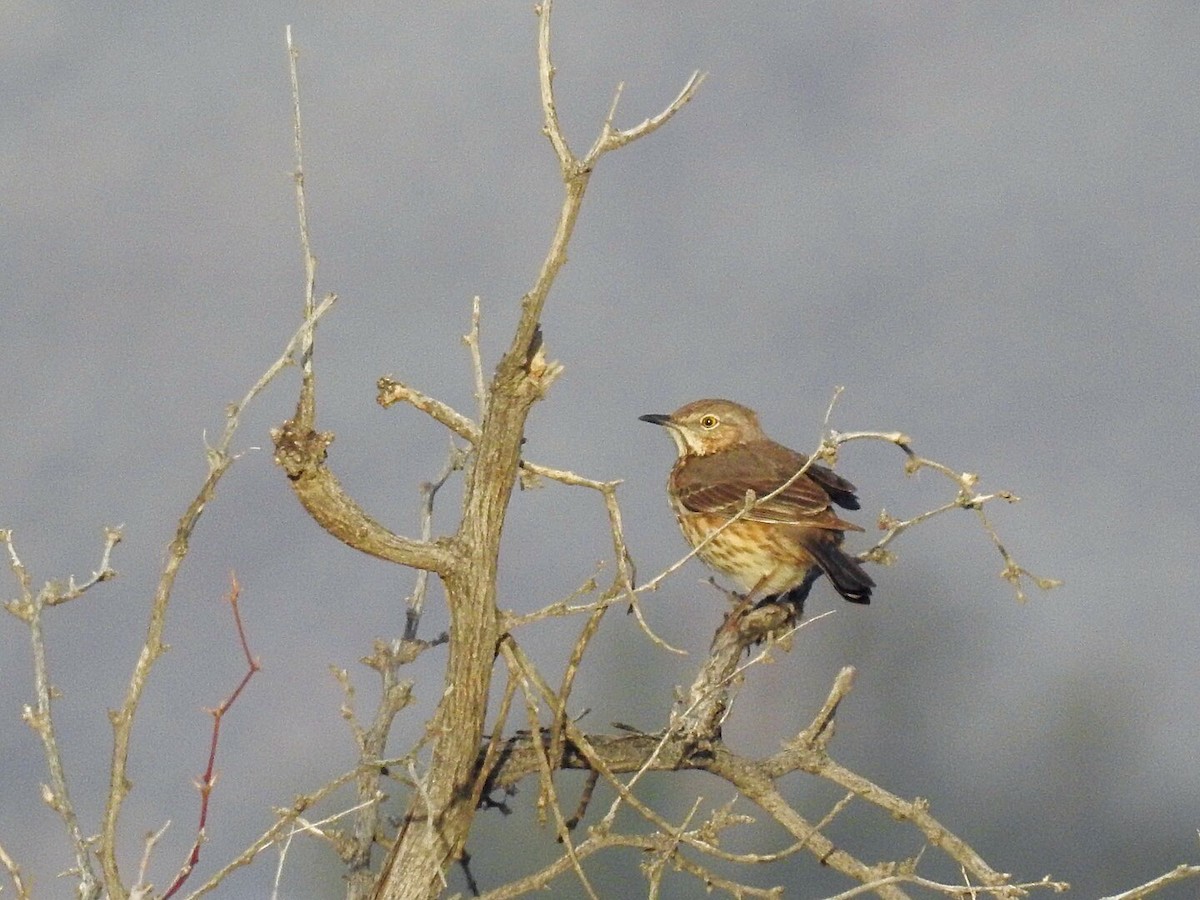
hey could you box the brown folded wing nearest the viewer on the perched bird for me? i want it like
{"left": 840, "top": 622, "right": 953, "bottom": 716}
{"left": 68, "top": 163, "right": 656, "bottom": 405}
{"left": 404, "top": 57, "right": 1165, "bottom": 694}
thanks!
{"left": 673, "top": 444, "right": 862, "bottom": 530}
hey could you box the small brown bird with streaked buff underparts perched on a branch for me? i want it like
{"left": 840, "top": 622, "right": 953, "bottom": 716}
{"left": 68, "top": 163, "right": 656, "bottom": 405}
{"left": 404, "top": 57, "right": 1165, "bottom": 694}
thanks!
{"left": 638, "top": 400, "right": 875, "bottom": 612}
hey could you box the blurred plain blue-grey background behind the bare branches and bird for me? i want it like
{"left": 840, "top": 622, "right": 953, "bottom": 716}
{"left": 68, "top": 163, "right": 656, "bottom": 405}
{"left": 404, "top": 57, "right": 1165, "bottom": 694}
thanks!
{"left": 0, "top": 0, "right": 1200, "bottom": 898}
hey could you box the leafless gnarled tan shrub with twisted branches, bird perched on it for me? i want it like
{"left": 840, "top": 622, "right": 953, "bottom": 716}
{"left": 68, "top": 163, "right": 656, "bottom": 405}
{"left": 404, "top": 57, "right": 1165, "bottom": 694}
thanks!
{"left": 0, "top": 0, "right": 1198, "bottom": 900}
